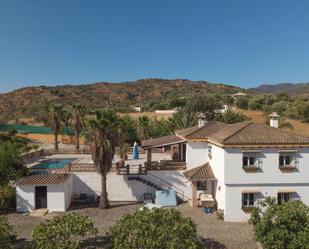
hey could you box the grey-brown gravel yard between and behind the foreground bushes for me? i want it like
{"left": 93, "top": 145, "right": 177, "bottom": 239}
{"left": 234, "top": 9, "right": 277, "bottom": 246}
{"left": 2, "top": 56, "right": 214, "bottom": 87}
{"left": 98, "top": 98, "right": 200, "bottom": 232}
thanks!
{"left": 7, "top": 203, "right": 258, "bottom": 249}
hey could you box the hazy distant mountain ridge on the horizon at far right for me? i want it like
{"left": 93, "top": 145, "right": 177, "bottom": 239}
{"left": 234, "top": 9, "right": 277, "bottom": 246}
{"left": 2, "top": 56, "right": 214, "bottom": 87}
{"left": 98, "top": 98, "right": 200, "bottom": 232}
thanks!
{"left": 248, "top": 83, "right": 309, "bottom": 94}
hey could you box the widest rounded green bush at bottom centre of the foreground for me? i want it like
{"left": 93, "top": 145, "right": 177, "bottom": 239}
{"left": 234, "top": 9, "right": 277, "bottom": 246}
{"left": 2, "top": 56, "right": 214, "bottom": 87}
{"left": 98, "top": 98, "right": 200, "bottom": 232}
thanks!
{"left": 107, "top": 209, "right": 200, "bottom": 249}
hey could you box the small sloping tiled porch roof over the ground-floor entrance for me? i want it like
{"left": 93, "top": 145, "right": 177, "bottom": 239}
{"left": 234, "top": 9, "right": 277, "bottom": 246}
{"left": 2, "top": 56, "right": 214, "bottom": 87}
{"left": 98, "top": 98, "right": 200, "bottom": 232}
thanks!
{"left": 183, "top": 162, "right": 217, "bottom": 181}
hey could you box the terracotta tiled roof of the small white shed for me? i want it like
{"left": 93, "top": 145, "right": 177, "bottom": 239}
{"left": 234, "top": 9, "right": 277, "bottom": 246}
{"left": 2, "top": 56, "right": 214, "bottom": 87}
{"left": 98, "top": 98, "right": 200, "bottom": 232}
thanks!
{"left": 16, "top": 173, "right": 71, "bottom": 185}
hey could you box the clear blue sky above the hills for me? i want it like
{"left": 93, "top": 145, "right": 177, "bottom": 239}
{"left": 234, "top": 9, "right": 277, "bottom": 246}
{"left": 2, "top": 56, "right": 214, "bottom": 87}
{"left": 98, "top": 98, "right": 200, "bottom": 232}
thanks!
{"left": 0, "top": 0, "right": 309, "bottom": 92}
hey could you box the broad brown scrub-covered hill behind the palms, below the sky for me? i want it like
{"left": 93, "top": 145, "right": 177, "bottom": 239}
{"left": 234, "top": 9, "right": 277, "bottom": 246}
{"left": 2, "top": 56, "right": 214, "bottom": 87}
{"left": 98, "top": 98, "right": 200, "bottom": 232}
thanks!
{"left": 0, "top": 79, "right": 242, "bottom": 122}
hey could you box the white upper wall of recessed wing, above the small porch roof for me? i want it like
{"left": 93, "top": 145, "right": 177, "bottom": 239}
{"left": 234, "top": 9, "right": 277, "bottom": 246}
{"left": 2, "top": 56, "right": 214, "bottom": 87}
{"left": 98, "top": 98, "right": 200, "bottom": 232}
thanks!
{"left": 186, "top": 142, "right": 208, "bottom": 169}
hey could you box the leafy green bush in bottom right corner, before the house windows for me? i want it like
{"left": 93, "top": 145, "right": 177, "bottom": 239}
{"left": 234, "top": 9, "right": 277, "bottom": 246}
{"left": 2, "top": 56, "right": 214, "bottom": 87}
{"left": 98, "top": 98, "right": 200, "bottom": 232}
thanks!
{"left": 250, "top": 199, "right": 309, "bottom": 249}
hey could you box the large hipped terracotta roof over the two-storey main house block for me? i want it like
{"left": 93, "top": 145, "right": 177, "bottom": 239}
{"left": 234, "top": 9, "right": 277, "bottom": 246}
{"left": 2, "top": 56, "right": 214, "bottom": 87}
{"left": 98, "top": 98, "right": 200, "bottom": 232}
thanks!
{"left": 209, "top": 122, "right": 309, "bottom": 145}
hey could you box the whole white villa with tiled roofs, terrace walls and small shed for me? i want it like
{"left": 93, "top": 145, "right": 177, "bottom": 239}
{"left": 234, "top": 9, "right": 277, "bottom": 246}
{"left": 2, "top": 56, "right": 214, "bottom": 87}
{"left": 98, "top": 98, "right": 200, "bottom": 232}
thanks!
{"left": 16, "top": 114, "right": 309, "bottom": 221}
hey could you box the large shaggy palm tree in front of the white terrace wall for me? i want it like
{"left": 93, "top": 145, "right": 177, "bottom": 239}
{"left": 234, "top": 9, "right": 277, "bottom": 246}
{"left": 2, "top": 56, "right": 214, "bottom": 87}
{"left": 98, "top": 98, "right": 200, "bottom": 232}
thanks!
{"left": 85, "top": 110, "right": 121, "bottom": 208}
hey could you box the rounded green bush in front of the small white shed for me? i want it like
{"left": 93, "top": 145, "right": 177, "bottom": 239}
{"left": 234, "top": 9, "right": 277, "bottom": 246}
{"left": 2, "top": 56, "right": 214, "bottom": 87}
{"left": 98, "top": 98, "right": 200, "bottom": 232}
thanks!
{"left": 31, "top": 213, "right": 97, "bottom": 249}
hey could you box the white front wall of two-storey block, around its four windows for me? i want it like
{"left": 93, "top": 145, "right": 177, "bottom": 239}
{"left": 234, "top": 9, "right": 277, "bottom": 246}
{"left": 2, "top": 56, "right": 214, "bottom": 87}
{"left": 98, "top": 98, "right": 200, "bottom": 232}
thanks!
{"left": 220, "top": 148, "right": 309, "bottom": 221}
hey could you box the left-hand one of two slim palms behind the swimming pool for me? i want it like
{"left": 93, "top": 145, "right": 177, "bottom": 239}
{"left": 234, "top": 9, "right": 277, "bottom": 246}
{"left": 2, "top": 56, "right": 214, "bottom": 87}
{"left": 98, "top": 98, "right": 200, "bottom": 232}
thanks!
{"left": 49, "top": 104, "right": 63, "bottom": 150}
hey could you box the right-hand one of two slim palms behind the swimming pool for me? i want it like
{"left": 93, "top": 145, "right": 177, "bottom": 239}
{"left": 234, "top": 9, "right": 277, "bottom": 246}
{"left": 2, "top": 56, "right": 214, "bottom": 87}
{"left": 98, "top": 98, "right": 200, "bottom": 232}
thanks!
{"left": 70, "top": 104, "right": 85, "bottom": 150}
